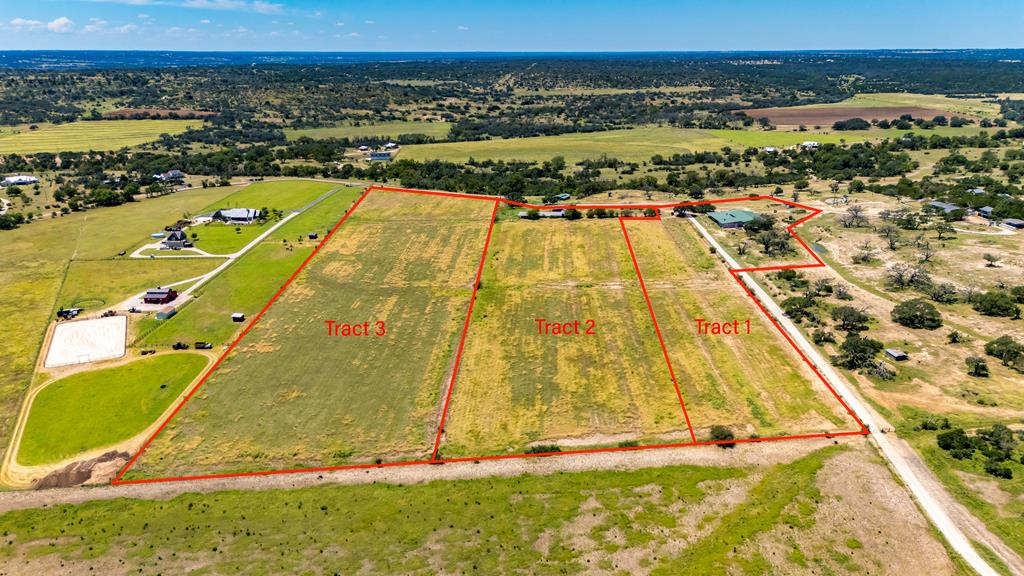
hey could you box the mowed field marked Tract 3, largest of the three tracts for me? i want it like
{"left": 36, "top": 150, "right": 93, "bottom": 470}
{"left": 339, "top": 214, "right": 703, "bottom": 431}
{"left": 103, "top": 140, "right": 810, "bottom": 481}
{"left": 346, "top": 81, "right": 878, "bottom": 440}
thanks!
{"left": 121, "top": 191, "right": 493, "bottom": 478}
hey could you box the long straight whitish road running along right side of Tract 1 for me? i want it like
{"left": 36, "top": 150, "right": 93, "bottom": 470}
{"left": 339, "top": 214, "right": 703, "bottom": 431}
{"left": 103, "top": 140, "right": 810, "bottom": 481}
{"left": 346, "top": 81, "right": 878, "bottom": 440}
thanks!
{"left": 690, "top": 218, "right": 998, "bottom": 576}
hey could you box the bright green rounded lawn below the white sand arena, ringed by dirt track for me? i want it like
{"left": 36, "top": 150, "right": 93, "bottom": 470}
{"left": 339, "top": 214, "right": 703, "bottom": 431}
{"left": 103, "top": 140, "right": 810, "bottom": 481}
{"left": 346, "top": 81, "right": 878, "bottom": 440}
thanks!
{"left": 17, "top": 354, "right": 208, "bottom": 465}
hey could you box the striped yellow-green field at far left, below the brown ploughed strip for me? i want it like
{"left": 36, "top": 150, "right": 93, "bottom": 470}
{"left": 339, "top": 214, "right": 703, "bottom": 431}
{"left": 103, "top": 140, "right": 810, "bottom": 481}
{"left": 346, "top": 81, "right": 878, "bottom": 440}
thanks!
{"left": 0, "top": 120, "right": 203, "bottom": 154}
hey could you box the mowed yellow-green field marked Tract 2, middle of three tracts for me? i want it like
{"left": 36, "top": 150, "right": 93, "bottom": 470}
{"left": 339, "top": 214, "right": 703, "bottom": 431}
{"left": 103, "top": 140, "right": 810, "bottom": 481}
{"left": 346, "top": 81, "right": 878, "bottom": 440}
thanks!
{"left": 442, "top": 218, "right": 690, "bottom": 456}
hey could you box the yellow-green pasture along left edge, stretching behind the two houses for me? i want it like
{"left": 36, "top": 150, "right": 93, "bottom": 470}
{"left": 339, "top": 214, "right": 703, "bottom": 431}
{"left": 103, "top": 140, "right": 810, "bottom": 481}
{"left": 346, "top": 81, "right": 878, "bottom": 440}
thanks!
{"left": 0, "top": 182, "right": 239, "bottom": 471}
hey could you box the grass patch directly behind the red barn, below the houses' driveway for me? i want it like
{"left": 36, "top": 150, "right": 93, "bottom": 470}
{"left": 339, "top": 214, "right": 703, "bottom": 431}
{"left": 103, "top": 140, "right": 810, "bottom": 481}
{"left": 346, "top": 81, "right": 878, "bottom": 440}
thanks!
{"left": 57, "top": 258, "right": 222, "bottom": 312}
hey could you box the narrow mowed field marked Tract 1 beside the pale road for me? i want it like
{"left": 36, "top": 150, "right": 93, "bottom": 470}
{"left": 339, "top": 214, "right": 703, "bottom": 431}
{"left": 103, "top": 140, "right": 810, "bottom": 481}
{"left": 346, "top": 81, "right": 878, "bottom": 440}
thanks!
{"left": 627, "top": 218, "right": 857, "bottom": 440}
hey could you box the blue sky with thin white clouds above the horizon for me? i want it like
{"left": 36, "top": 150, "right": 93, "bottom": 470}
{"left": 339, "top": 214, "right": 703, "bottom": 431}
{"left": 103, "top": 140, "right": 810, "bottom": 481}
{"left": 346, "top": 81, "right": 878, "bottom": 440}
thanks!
{"left": 0, "top": 0, "right": 1024, "bottom": 51}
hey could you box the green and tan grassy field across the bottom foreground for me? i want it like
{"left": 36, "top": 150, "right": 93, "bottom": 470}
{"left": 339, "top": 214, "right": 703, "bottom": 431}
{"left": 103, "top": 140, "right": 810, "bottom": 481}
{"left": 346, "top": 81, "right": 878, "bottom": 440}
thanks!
{"left": 0, "top": 440, "right": 969, "bottom": 576}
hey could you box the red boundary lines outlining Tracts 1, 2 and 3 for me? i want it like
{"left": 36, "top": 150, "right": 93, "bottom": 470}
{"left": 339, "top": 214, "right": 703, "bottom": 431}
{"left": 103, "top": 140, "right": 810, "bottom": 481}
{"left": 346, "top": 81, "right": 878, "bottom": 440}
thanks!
{"left": 111, "top": 186, "right": 869, "bottom": 485}
